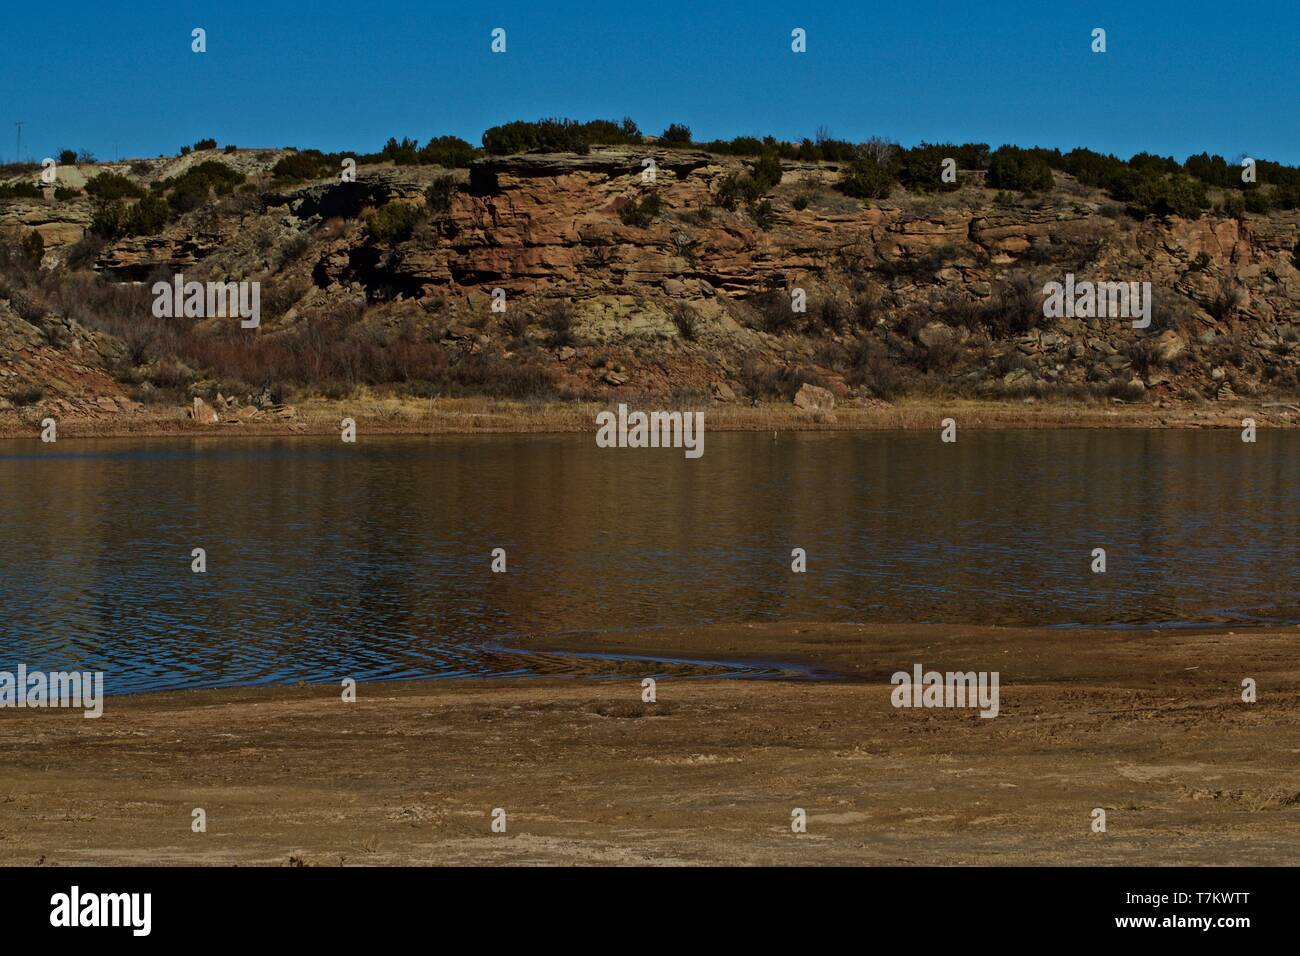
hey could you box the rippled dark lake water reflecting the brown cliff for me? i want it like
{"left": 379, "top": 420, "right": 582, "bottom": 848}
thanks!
{"left": 0, "top": 429, "right": 1300, "bottom": 693}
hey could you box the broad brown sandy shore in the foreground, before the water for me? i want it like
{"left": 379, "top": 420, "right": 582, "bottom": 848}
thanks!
{"left": 0, "top": 624, "right": 1300, "bottom": 865}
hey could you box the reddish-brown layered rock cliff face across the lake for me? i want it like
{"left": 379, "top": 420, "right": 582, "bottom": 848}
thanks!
{"left": 0, "top": 147, "right": 1300, "bottom": 418}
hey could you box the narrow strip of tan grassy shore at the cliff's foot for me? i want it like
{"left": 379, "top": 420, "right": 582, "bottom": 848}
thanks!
{"left": 0, "top": 395, "right": 1300, "bottom": 440}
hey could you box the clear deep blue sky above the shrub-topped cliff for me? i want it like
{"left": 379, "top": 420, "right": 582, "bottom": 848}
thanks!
{"left": 0, "top": 0, "right": 1300, "bottom": 164}
